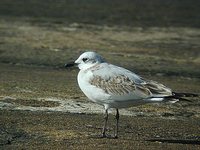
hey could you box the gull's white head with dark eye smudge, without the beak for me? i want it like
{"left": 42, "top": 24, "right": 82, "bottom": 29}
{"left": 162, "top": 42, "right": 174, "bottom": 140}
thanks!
{"left": 75, "top": 52, "right": 105, "bottom": 69}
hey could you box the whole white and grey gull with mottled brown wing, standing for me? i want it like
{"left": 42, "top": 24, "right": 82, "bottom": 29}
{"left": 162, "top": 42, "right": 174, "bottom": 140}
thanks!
{"left": 65, "top": 51, "right": 197, "bottom": 138}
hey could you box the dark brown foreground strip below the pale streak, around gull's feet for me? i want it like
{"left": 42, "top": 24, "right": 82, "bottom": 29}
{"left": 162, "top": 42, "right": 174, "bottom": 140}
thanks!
{"left": 0, "top": 110, "right": 200, "bottom": 150}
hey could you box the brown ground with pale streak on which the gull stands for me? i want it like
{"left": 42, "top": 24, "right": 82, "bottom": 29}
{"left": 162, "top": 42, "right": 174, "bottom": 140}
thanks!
{"left": 0, "top": 64, "right": 200, "bottom": 149}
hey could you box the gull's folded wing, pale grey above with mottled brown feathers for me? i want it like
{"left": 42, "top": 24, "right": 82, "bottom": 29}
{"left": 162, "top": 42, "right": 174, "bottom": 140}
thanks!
{"left": 89, "top": 64, "right": 171, "bottom": 101}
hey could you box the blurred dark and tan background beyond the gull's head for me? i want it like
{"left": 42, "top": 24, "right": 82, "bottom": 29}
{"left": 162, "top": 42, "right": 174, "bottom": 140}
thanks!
{"left": 0, "top": 0, "right": 200, "bottom": 77}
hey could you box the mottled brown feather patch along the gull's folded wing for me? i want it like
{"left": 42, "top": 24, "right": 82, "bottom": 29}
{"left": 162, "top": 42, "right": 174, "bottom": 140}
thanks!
{"left": 90, "top": 75, "right": 171, "bottom": 96}
